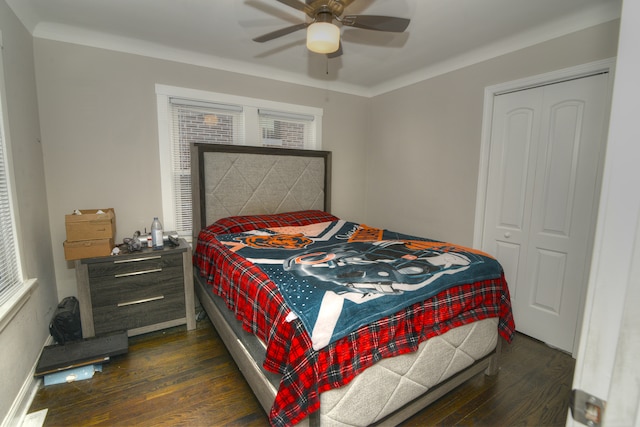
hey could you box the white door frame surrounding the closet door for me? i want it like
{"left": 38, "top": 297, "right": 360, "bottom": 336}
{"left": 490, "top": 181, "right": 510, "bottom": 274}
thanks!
{"left": 473, "top": 58, "right": 616, "bottom": 357}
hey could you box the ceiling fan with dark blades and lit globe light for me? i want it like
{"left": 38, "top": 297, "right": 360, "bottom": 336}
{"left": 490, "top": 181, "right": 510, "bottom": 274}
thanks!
{"left": 253, "top": 0, "right": 410, "bottom": 58}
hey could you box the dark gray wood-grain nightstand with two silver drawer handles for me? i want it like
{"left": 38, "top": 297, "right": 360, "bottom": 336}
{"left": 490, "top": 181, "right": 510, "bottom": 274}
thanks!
{"left": 75, "top": 239, "right": 196, "bottom": 338}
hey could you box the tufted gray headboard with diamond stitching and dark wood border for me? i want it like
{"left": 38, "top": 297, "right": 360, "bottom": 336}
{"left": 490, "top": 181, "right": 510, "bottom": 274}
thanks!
{"left": 191, "top": 144, "right": 331, "bottom": 237}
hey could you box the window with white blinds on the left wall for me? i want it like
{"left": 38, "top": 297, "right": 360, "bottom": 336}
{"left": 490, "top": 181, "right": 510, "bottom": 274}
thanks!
{"left": 0, "top": 33, "right": 23, "bottom": 306}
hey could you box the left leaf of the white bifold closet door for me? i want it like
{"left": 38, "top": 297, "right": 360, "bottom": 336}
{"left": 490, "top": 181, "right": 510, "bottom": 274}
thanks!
{"left": 482, "top": 88, "right": 542, "bottom": 314}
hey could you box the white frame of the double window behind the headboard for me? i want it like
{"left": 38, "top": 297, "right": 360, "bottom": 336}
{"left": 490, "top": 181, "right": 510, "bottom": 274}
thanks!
{"left": 155, "top": 84, "right": 323, "bottom": 242}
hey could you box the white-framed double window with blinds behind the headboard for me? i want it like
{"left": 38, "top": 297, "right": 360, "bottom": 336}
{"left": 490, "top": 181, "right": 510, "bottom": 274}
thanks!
{"left": 156, "top": 85, "right": 322, "bottom": 241}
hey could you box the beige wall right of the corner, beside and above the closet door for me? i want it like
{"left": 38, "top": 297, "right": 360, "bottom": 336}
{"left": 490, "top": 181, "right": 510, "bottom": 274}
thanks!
{"left": 365, "top": 21, "right": 619, "bottom": 245}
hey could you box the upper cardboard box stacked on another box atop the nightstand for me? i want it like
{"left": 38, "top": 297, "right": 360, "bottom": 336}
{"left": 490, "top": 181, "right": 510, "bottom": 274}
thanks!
{"left": 65, "top": 208, "right": 116, "bottom": 242}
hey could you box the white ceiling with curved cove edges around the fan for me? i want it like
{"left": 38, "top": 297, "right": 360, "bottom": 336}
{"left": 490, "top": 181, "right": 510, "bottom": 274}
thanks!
{"left": 6, "top": 0, "right": 621, "bottom": 96}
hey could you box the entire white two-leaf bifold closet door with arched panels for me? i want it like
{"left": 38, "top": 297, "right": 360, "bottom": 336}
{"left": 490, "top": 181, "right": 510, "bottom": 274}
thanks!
{"left": 483, "top": 75, "right": 607, "bottom": 352}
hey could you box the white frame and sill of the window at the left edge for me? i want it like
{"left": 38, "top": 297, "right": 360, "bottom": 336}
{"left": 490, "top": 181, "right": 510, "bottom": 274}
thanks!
{"left": 0, "top": 32, "right": 28, "bottom": 324}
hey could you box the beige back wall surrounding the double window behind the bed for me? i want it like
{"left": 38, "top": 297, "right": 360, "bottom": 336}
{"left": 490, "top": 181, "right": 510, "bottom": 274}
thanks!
{"left": 34, "top": 39, "right": 369, "bottom": 297}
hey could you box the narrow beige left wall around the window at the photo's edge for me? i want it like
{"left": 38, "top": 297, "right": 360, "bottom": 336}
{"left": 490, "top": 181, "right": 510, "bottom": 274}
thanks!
{"left": 0, "top": 0, "right": 58, "bottom": 422}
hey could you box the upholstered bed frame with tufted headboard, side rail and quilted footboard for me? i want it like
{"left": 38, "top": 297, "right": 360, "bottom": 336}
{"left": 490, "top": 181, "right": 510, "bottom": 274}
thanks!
{"left": 191, "top": 144, "right": 501, "bottom": 425}
